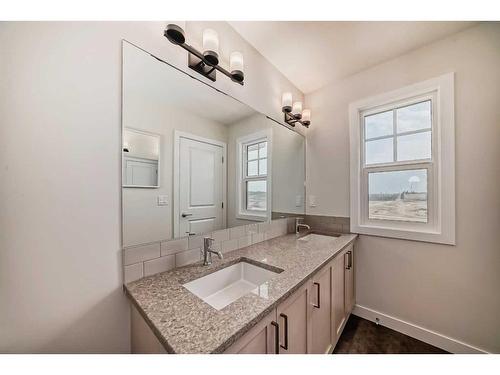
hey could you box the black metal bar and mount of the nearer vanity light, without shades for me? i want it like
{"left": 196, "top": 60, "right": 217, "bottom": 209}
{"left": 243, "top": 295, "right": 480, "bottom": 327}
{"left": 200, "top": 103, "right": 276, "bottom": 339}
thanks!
{"left": 163, "top": 24, "right": 244, "bottom": 86}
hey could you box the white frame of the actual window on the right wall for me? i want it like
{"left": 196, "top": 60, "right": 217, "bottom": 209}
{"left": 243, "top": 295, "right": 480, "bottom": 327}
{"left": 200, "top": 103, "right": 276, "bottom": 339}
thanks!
{"left": 349, "top": 73, "right": 455, "bottom": 245}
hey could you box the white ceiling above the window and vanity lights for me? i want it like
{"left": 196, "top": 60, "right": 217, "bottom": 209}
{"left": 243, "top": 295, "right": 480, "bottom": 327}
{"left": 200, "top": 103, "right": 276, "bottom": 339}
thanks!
{"left": 229, "top": 21, "right": 475, "bottom": 94}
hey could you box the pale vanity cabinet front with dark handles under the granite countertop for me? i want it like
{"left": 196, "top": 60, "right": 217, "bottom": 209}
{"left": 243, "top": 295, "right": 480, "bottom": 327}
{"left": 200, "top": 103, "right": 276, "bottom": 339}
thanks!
{"left": 226, "top": 244, "right": 355, "bottom": 354}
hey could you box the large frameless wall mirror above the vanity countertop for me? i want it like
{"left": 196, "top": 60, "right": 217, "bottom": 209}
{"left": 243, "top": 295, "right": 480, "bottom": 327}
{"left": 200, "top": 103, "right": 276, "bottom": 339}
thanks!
{"left": 122, "top": 41, "right": 305, "bottom": 247}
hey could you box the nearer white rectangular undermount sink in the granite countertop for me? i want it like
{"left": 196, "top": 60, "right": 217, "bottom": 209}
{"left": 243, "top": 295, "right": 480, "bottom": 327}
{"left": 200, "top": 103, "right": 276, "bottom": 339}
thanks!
{"left": 183, "top": 261, "right": 278, "bottom": 310}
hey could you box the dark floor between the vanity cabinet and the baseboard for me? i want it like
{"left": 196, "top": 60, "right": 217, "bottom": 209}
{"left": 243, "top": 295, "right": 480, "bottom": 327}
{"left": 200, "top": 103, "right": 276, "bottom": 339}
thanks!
{"left": 333, "top": 315, "right": 447, "bottom": 354}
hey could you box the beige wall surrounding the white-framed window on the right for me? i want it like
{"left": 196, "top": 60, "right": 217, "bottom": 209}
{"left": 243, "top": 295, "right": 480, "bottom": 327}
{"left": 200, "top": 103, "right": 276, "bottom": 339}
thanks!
{"left": 306, "top": 23, "right": 500, "bottom": 352}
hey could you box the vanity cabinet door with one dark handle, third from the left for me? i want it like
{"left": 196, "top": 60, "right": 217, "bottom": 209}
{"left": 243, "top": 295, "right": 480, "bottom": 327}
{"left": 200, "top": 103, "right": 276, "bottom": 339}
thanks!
{"left": 310, "top": 265, "right": 332, "bottom": 354}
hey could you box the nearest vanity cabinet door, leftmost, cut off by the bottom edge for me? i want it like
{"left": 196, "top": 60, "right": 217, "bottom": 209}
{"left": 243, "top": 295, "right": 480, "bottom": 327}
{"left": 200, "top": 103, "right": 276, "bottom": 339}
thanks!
{"left": 225, "top": 309, "right": 279, "bottom": 354}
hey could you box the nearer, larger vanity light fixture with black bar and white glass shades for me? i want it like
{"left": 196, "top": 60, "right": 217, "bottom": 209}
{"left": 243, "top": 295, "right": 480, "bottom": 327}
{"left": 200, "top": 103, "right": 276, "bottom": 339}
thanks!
{"left": 163, "top": 24, "right": 245, "bottom": 85}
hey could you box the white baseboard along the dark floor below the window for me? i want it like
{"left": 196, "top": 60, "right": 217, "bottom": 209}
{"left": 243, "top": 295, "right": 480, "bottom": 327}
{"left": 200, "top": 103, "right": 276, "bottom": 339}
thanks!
{"left": 352, "top": 305, "right": 488, "bottom": 354}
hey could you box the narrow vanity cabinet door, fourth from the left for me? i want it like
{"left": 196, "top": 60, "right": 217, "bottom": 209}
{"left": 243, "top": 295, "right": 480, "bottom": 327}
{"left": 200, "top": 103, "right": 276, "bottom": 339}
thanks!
{"left": 332, "top": 251, "right": 346, "bottom": 342}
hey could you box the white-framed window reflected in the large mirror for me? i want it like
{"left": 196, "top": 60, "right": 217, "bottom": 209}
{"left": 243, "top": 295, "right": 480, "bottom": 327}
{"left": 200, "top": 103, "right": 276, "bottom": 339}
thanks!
{"left": 236, "top": 131, "right": 271, "bottom": 221}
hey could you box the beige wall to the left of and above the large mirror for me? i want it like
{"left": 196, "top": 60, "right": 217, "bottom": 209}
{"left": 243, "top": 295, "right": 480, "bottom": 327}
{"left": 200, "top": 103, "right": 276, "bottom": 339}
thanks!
{"left": 0, "top": 22, "right": 301, "bottom": 352}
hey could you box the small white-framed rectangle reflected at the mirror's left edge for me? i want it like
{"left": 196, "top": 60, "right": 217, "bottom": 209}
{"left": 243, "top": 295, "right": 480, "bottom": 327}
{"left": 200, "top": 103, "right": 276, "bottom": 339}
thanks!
{"left": 122, "top": 128, "right": 161, "bottom": 188}
